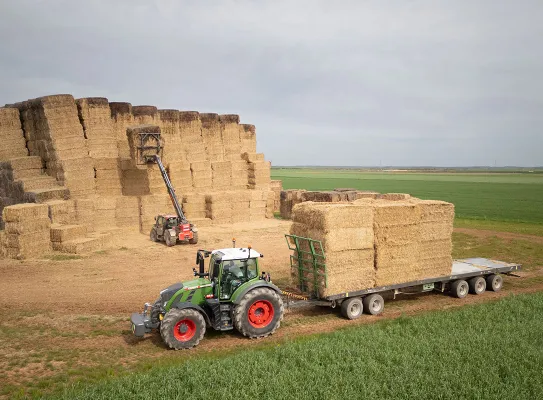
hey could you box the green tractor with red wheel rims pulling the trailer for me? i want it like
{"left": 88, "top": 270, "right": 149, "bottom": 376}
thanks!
{"left": 131, "top": 241, "right": 284, "bottom": 350}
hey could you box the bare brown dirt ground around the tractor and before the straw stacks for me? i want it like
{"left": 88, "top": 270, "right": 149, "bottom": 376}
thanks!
{"left": 0, "top": 220, "right": 543, "bottom": 397}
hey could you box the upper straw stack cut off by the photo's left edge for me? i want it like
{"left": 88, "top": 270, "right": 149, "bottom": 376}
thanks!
{"left": 0, "top": 108, "right": 28, "bottom": 161}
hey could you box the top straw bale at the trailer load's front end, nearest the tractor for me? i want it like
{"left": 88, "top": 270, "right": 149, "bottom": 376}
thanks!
{"left": 292, "top": 202, "right": 373, "bottom": 231}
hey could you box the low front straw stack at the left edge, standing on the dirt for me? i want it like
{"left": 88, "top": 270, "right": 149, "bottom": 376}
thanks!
{"left": 2, "top": 203, "right": 51, "bottom": 259}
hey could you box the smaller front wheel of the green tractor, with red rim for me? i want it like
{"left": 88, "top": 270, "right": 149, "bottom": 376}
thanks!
{"left": 160, "top": 308, "right": 206, "bottom": 350}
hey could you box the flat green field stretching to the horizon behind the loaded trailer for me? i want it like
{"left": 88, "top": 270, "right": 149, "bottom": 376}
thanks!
{"left": 272, "top": 169, "right": 543, "bottom": 224}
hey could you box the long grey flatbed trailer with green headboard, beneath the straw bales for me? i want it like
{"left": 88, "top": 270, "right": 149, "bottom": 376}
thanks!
{"left": 283, "top": 235, "right": 521, "bottom": 319}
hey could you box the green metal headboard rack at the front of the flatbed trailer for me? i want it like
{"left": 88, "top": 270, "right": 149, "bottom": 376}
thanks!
{"left": 285, "top": 235, "right": 328, "bottom": 297}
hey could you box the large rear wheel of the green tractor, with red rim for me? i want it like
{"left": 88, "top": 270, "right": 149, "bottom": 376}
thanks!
{"left": 232, "top": 287, "right": 284, "bottom": 339}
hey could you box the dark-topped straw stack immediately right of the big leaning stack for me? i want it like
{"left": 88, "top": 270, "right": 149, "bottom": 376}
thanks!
{"left": 76, "top": 97, "right": 119, "bottom": 160}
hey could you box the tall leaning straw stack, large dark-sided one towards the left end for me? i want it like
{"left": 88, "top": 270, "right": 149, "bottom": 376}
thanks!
{"left": 18, "top": 95, "right": 95, "bottom": 198}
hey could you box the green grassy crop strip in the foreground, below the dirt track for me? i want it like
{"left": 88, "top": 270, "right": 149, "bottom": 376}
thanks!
{"left": 49, "top": 293, "right": 543, "bottom": 400}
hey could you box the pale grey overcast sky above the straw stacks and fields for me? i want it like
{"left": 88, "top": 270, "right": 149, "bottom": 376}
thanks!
{"left": 0, "top": 0, "right": 543, "bottom": 166}
